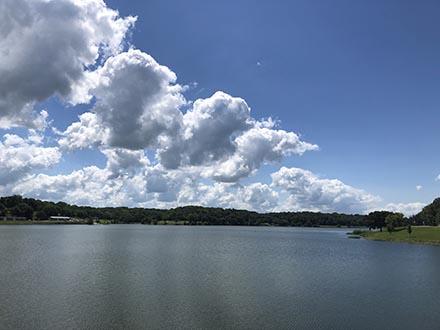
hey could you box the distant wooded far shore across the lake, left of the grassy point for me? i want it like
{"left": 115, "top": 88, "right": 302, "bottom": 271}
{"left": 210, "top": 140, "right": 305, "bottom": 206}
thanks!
{"left": 0, "top": 195, "right": 367, "bottom": 227}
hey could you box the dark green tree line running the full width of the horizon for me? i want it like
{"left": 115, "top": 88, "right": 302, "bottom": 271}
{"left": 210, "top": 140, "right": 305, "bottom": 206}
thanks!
{"left": 0, "top": 195, "right": 440, "bottom": 230}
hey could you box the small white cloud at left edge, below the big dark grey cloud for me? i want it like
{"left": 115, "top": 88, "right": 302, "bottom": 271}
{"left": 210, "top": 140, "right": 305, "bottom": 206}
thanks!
{"left": 0, "top": 134, "right": 61, "bottom": 186}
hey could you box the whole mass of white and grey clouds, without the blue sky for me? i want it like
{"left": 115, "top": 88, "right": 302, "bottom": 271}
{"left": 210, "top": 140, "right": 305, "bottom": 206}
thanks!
{"left": 0, "top": 0, "right": 420, "bottom": 212}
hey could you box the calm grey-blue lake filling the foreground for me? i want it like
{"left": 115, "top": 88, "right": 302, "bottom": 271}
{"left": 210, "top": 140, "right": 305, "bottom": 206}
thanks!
{"left": 0, "top": 225, "right": 440, "bottom": 329}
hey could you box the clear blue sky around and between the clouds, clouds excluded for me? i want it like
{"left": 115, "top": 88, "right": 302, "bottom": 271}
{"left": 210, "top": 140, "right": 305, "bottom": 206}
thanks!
{"left": 0, "top": 0, "right": 440, "bottom": 214}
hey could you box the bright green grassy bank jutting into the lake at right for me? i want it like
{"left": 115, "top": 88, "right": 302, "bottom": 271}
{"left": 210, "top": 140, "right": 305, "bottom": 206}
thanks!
{"left": 361, "top": 226, "right": 440, "bottom": 245}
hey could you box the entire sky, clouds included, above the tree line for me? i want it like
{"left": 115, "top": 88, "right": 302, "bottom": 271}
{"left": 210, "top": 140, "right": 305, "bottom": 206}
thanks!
{"left": 0, "top": 0, "right": 440, "bottom": 215}
